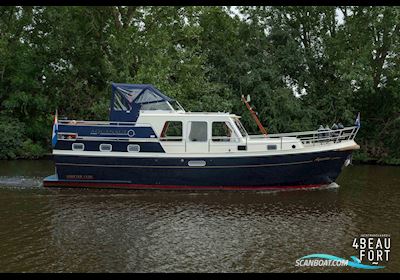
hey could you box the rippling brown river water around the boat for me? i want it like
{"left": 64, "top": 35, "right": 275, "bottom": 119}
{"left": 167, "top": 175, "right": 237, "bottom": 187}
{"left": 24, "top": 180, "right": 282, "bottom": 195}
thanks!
{"left": 0, "top": 160, "right": 400, "bottom": 272}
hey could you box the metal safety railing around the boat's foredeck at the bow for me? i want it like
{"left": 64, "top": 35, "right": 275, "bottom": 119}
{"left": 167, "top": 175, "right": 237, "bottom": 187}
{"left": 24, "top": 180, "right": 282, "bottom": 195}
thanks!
{"left": 248, "top": 126, "right": 359, "bottom": 146}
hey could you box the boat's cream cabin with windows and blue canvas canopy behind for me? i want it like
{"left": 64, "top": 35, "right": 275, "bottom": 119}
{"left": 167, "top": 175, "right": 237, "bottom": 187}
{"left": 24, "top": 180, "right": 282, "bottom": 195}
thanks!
{"left": 110, "top": 83, "right": 301, "bottom": 153}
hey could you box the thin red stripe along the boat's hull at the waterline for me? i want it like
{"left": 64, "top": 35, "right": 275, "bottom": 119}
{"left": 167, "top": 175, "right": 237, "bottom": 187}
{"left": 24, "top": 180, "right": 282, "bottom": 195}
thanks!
{"left": 43, "top": 181, "right": 321, "bottom": 190}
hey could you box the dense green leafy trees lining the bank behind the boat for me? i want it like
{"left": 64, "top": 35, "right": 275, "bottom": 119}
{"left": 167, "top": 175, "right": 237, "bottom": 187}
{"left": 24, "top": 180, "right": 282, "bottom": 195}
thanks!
{"left": 0, "top": 6, "right": 400, "bottom": 164}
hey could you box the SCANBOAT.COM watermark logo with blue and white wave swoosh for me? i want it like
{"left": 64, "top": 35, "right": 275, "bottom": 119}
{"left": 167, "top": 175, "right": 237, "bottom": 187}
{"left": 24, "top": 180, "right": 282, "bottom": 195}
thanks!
{"left": 296, "top": 254, "right": 384, "bottom": 269}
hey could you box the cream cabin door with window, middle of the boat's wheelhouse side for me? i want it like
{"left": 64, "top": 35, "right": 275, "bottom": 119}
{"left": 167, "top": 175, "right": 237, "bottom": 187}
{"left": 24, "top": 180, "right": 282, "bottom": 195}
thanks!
{"left": 186, "top": 121, "right": 209, "bottom": 154}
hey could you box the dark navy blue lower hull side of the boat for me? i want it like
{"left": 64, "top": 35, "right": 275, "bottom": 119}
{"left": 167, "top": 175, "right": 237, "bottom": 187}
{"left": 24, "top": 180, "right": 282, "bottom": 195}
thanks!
{"left": 50, "top": 151, "right": 351, "bottom": 187}
